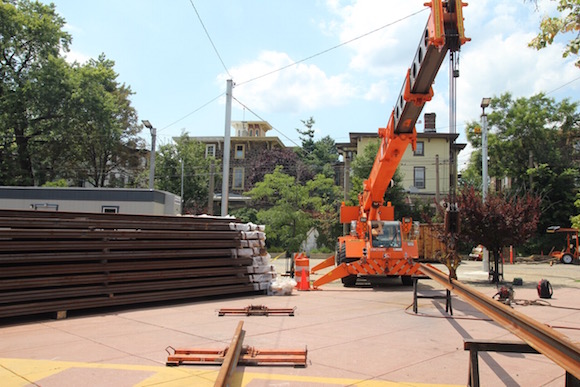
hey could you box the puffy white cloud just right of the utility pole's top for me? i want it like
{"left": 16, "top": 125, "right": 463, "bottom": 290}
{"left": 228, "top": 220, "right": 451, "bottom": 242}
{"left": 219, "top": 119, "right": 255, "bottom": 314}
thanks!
{"left": 219, "top": 51, "right": 357, "bottom": 113}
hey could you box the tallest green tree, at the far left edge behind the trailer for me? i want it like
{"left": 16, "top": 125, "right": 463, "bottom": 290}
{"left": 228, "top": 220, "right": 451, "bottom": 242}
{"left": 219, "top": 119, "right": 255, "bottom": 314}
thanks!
{"left": 0, "top": 0, "right": 71, "bottom": 185}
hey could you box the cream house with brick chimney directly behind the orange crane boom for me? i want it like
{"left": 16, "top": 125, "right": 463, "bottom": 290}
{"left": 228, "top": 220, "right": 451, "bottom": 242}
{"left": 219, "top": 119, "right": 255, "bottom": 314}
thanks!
{"left": 337, "top": 113, "right": 466, "bottom": 206}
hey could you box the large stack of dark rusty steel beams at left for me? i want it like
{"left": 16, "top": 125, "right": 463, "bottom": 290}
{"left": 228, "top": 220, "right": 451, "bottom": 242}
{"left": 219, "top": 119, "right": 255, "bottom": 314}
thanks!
{"left": 0, "top": 210, "right": 257, "bottom": 318}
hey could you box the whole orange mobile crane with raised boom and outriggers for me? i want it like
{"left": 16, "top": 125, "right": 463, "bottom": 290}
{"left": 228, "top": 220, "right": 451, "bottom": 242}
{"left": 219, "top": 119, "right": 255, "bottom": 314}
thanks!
{"left": 312, "top": 0, "right": 470, "bottom": 287}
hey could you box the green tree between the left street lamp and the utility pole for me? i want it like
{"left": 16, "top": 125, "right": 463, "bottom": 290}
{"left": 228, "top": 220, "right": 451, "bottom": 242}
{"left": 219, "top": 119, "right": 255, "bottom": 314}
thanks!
{"left": 155, "top": 133, "right": 216, "bottom": 214}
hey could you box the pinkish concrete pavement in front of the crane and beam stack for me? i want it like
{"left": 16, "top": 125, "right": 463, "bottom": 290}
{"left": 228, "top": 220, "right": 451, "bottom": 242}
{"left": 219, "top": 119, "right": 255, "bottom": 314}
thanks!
{"left": 0, "top": 262, "right": 580, "bottom": 387}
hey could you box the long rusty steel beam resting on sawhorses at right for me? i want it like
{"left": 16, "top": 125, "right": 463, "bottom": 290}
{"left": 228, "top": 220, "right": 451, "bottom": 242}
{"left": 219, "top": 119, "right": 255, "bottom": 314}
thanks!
{"left": 420, "top": 264, "right": 580, "bottom": 379}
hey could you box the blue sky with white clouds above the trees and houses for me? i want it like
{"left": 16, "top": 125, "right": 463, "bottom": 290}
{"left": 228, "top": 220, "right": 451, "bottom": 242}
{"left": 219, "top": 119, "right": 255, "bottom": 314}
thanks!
{"left": 46, "top": 0, "right": 580, "bottom": 168}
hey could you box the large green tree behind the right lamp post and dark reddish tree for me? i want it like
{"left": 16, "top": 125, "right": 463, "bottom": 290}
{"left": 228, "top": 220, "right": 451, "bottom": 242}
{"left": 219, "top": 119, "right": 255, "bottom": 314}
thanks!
{"left": 463, "top": 93, "right": 580, "bottom": 248}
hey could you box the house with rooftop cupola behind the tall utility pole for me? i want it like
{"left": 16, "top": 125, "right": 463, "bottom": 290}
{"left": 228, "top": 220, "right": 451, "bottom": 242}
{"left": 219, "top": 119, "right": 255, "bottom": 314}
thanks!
{"left": 190, "top": 121, "right": 286, "bottom": 215}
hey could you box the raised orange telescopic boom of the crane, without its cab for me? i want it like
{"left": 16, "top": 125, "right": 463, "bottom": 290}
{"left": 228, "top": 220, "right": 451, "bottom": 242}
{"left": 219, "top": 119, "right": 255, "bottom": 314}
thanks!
{"left": 341, "top": 0, "right": 469, "bottom": 222}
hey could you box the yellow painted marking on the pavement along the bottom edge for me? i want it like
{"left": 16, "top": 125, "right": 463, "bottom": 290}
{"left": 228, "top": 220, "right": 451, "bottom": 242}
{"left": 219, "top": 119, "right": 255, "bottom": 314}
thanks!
{"left": 0, "top": 359, "right": 462, "bottom": 387}
